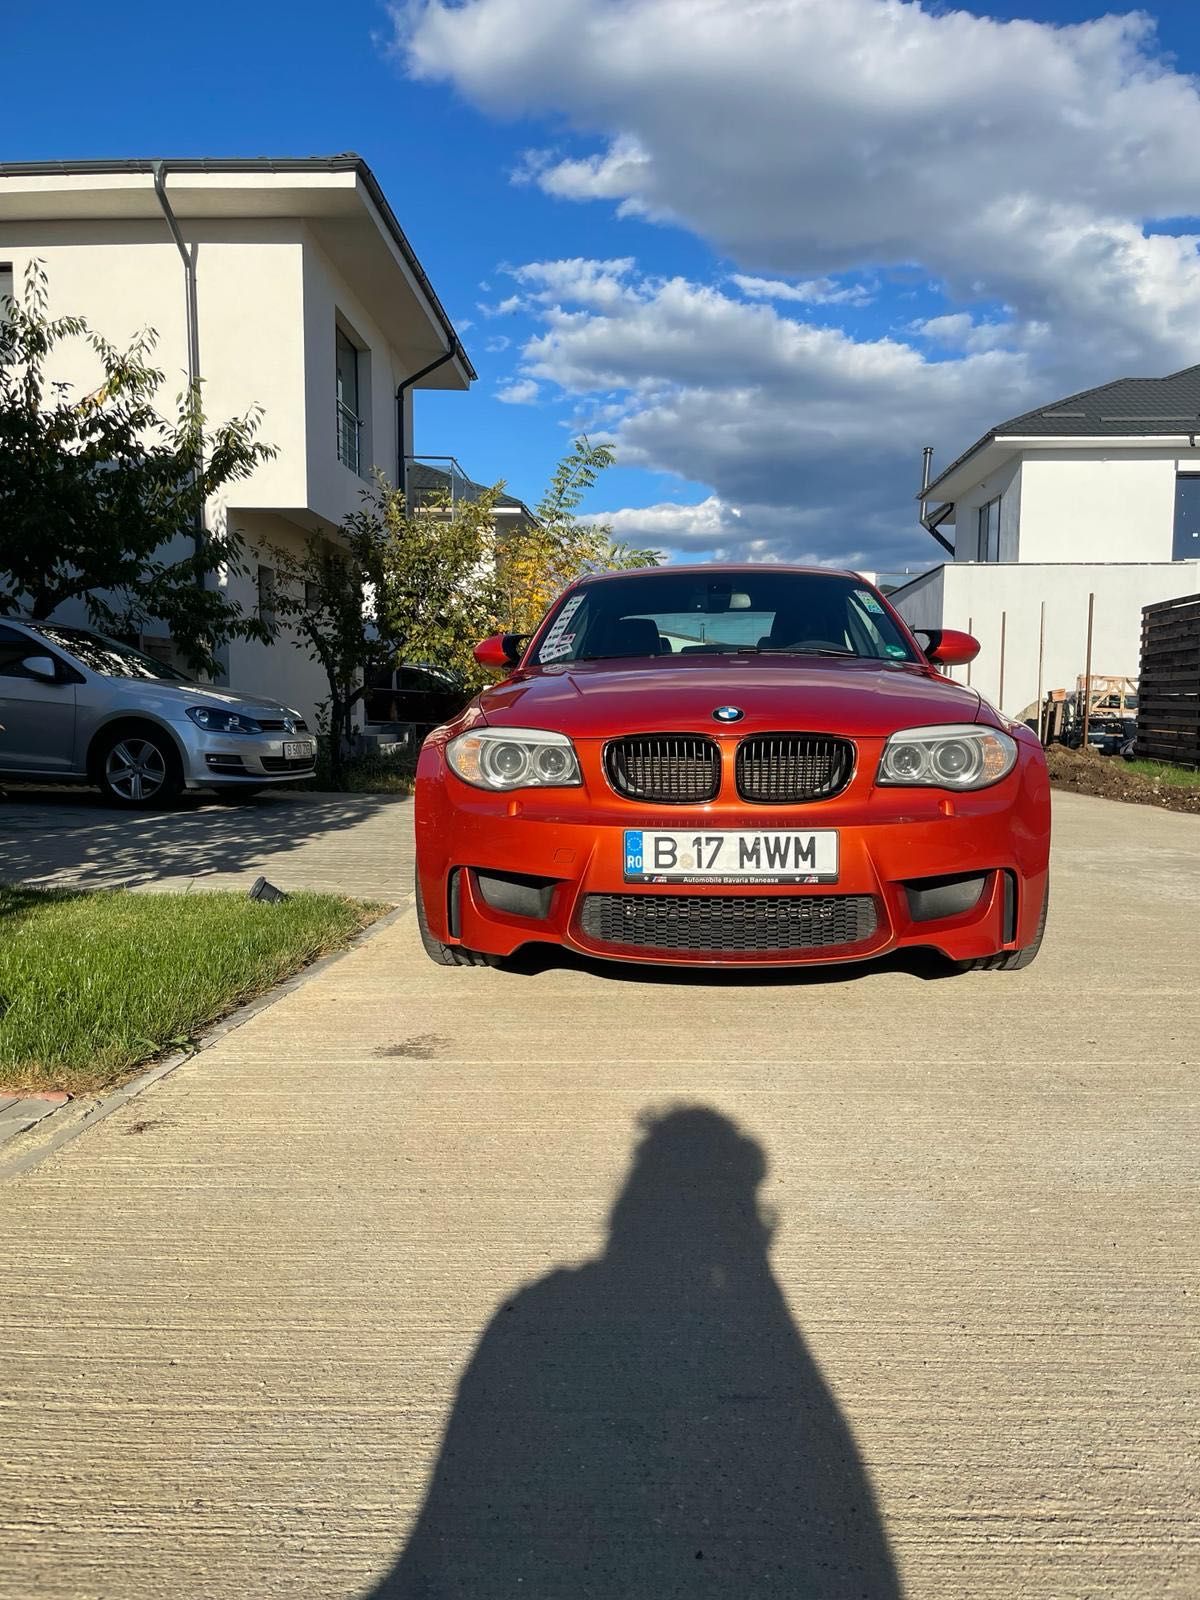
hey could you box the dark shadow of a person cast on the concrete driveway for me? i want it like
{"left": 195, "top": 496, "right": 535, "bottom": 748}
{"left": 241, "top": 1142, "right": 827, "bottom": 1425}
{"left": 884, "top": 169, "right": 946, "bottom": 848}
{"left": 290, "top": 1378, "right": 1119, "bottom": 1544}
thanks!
{"left": 371, "top": 1107, "right": 901, "bottom": 1600}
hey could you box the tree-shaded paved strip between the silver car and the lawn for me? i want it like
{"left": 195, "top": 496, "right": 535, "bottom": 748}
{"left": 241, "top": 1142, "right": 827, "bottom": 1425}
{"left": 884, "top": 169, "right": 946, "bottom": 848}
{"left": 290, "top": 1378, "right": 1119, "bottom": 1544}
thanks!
{"left": 0, "top": 789, "right": 413, "bottom": 902}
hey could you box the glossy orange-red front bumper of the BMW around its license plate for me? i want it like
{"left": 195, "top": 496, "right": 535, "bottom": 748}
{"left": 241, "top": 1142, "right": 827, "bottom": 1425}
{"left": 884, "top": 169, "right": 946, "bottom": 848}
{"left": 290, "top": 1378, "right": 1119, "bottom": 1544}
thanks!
{"left": 416, "top": 742, "right": 1050, "bottom": 966}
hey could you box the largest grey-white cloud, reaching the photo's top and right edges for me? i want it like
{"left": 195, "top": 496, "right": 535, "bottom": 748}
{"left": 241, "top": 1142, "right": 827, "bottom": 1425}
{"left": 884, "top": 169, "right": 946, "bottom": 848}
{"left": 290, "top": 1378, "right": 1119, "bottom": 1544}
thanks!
{"left": 394, "top": 0, "right": 1200, "bottom": 370}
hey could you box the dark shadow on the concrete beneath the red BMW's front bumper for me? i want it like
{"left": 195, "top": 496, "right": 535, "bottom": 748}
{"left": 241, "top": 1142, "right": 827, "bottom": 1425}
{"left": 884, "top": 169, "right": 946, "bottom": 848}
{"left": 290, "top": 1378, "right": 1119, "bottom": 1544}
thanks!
{"left": 499, "top": 944, "right": 962, "bottom": 989}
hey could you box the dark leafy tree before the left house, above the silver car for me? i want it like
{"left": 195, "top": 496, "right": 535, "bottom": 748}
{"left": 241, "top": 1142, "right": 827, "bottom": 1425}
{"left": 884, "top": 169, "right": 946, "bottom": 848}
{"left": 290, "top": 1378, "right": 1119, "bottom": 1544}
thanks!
{"left": 0, "top": 261, "right": 275, "bottom": 670}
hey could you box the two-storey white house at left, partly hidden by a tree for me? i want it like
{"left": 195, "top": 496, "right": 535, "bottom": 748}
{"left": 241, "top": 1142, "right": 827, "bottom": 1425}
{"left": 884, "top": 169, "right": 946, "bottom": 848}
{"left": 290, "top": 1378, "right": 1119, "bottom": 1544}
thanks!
{"left": 0, "top": 155, "right": 475, "bottom": 729}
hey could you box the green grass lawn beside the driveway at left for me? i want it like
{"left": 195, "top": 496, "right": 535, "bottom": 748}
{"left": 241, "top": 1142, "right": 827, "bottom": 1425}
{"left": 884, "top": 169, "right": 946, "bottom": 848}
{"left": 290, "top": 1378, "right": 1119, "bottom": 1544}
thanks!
{"left": 0, "top": 886, "right": 384, "bottom": 1093}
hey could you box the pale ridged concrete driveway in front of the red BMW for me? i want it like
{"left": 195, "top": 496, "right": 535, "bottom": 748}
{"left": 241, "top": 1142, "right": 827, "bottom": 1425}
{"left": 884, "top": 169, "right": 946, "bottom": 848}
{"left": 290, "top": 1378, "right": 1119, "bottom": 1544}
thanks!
{"left": 0, "top": 797, "right": 1200, "bottom": 1600}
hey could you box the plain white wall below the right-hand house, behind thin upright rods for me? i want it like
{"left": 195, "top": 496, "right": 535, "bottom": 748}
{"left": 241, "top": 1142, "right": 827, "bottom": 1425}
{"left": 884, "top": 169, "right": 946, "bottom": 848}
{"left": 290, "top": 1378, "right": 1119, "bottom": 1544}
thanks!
{"left": 891, "top": 562, "right": 1200, "bottom": 717}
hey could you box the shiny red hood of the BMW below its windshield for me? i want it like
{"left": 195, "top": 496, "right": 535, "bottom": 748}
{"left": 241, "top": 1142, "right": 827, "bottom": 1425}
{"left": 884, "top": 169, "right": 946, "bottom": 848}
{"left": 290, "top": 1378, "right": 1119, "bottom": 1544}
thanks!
{"left": 478, "top": 654, "right": 990, "bottom": 739}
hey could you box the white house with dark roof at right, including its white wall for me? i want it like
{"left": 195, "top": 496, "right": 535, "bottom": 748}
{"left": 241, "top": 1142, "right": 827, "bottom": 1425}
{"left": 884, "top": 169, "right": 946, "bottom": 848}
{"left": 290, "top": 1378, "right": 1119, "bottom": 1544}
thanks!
{"left": 891, "top": 366, "right": 1200, "bottom": 715}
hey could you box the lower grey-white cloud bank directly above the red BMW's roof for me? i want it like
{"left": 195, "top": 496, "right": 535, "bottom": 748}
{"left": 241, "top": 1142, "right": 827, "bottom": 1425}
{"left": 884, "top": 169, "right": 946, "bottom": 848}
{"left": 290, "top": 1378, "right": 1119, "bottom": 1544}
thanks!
{"left": 502, "top": 262, "right": 1034, "bottom": 568}
